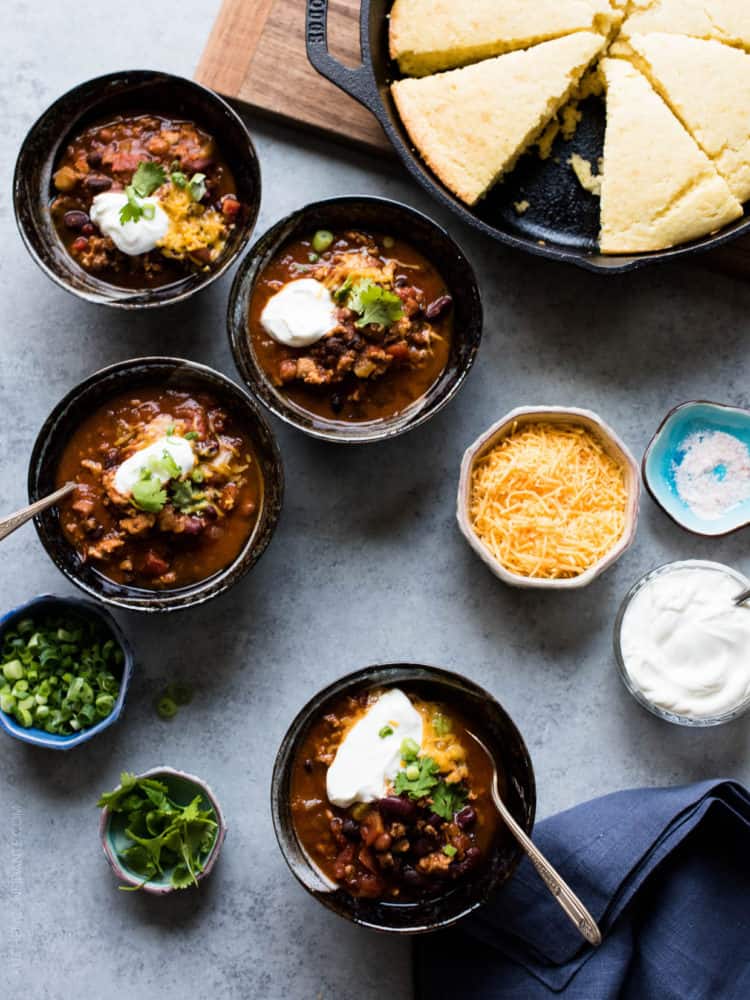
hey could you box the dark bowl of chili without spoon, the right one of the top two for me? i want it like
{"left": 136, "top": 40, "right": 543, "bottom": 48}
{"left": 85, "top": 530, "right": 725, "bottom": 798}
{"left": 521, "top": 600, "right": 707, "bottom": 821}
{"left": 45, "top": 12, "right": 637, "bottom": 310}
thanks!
{"left": 228, "top": 196, "right": 482, "bottom": 443}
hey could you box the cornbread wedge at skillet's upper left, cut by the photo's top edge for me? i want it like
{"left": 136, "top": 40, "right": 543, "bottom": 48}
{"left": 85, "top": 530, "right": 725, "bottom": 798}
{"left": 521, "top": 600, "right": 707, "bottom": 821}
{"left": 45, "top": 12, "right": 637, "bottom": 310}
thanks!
{"left": 389, "top": 0, "right": 622, "bottom": 76}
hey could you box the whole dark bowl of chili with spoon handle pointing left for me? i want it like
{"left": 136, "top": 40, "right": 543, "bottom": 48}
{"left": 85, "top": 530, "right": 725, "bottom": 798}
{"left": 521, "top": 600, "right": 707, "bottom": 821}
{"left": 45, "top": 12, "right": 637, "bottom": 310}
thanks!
{"left": 29, "top": 357, "right": 283, "bottom": 611}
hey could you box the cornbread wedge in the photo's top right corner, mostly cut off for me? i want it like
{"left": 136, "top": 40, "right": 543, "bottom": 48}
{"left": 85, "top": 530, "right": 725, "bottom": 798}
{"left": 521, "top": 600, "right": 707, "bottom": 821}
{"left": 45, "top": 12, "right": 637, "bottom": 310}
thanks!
{"left": 622, "top": 0, "right": 750, "bottom": 49}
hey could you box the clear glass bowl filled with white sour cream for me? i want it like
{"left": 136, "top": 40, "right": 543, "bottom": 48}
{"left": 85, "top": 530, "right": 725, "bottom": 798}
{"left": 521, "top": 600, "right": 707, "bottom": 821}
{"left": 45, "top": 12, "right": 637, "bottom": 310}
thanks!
{"left": 614, "top": 559, "right": 750, "bottom": 727}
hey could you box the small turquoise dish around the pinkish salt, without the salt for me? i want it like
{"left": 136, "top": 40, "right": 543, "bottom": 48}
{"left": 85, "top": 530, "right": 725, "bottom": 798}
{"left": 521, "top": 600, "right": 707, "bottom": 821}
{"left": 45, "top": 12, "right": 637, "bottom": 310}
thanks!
{"left": 643, "top": 400, "right": 750, "bottom": 538}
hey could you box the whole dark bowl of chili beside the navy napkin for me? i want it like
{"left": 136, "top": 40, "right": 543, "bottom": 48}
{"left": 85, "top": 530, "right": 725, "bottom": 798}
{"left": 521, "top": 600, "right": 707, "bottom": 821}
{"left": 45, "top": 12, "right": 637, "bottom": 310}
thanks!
{"left": 271, "top": 664, "right": 536, "bottom": 933}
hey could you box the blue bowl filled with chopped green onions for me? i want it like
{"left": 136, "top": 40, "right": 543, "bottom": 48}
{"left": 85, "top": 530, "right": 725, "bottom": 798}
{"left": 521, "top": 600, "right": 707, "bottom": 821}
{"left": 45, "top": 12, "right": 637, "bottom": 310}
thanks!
{"left": 0, "top": 594, "right": 133, "bottom": 750}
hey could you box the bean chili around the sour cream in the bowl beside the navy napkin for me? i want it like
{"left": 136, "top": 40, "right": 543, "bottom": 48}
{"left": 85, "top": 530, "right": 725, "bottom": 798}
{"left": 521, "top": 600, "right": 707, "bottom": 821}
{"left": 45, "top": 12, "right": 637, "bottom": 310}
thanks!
{"left": 291, "top": 690, "right": 498, "bottom": 902}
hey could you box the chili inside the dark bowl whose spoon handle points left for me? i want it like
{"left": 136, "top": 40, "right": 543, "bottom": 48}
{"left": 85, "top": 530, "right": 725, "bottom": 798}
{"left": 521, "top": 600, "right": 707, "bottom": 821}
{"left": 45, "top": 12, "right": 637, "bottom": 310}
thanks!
{"left": 57, "top": 388, "right": 262, "bottom": 590}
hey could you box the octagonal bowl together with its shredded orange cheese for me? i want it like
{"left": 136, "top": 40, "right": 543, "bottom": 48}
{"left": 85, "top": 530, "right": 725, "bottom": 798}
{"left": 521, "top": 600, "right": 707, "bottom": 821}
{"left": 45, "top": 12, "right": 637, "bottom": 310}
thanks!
{"left": 457, "top": 406, "right": 640, "bottom": 590}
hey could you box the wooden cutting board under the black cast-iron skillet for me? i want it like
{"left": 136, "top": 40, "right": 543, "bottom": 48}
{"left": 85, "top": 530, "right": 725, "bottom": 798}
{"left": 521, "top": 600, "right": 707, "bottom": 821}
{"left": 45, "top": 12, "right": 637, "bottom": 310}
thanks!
{"left": 195, "top": 0, "right": 750, "bottom": 280}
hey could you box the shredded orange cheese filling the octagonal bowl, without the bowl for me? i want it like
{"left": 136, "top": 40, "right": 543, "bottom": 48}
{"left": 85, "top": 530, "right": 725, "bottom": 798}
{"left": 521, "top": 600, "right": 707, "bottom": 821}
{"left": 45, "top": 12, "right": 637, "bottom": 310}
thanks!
{"left": 470, "top": 423, "right": 627, "bottom": 579}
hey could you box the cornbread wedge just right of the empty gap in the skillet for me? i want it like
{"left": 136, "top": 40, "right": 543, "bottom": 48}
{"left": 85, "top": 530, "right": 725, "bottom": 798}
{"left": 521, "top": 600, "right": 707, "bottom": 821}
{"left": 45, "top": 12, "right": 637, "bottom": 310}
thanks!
{"left": 599, "top": 59, "right": 742, "bottom": 253}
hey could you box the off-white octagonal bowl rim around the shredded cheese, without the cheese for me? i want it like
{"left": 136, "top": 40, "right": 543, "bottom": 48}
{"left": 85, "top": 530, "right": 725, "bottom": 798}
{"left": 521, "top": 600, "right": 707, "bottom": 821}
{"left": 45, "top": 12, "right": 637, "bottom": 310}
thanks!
{"left": 456, "top": 406, "right": 641, "bottom": 590}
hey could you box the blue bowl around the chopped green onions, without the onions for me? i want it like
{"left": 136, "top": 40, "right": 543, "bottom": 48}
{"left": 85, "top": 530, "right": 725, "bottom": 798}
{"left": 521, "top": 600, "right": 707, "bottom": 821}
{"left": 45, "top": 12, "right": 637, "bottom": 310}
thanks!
{"left": 0, "top": 594, "right": 133, "bottom": 750}
